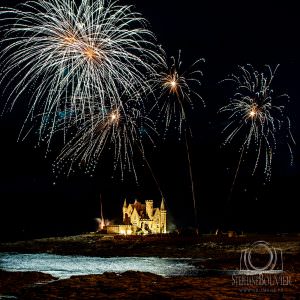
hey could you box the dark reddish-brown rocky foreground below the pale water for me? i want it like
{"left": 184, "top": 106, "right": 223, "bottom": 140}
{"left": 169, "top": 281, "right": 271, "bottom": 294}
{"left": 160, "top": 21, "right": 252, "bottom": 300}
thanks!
{"left": 1, "top": 271, "right": 300, "bottom": 300}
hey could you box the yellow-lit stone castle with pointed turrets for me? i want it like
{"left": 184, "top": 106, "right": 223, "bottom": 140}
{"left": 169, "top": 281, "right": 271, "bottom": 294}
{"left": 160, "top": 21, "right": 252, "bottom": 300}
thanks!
{"left": 106, "top": 199, "right": 167, "bottom": 234}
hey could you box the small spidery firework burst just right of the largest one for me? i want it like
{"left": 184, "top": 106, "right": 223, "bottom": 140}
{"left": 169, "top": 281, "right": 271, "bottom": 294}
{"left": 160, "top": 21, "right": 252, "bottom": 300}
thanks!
{"left": 152, "top": 51, "right": 204, "bottom": 135}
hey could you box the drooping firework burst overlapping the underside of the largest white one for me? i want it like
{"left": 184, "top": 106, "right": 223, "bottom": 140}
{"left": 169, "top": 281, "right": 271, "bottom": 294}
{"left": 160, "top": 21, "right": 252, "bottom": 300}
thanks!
{"left": 53, "top": 100, "right": 156, "bottom": 181}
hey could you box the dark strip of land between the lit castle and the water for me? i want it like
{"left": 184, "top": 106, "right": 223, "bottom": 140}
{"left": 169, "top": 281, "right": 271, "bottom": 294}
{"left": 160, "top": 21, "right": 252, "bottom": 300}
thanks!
{"left": 0, "top": 233, "right": 300, "bottom": 273}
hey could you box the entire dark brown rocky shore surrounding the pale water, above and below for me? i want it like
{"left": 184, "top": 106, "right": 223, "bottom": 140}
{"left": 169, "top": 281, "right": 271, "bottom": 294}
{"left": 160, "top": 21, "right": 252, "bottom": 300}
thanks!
{"left": 0, "top": 233, "right": 300, "bottom": 299}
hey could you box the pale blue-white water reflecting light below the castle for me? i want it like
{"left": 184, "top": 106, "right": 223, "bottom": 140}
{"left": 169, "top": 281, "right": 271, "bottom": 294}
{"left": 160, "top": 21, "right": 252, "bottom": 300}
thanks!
{"left": 0, "top": 253, "right": 198, "bottom": 279}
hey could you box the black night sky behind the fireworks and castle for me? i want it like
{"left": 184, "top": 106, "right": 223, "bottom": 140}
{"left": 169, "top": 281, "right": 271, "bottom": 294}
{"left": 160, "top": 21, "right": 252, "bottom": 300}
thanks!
{"left": 0, "top": 0, "right": 300, "bottom": 239}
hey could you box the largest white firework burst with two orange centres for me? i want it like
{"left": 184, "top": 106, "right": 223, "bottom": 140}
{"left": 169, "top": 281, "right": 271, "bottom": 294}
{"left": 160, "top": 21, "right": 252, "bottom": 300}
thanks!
{"left": 0, "top": 0, "right": 163, "bottom": 144}
